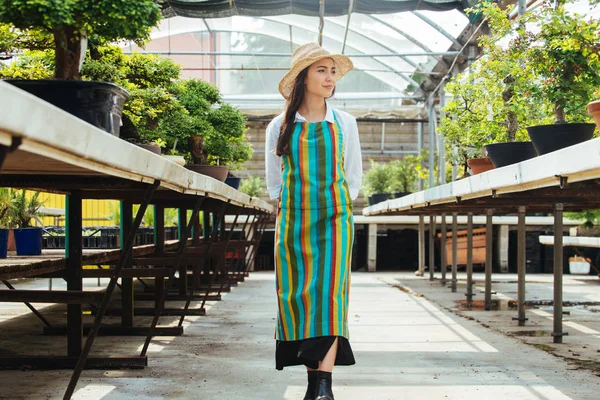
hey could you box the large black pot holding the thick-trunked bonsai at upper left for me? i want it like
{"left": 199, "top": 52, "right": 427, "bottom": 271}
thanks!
{"left": 5, "top": 79, "right": 129, "bottom": 136}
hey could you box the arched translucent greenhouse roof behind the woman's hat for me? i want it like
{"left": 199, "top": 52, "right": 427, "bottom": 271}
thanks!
{"left": 130, "top": 10, "right": 469, "bottom": 109}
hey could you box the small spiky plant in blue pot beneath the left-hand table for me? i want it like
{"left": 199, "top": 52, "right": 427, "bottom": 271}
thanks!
{"left": 10, "top": 190, "right": 43, "bottom": 256}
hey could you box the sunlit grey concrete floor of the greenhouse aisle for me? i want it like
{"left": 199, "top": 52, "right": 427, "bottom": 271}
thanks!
{"left": 0, "top": 272, "right": 600, "bottom": 400}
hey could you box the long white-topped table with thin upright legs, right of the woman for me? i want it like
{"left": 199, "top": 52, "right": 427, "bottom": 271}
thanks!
{"left": 363, "top": 139, "right": 600, "bottom": 350}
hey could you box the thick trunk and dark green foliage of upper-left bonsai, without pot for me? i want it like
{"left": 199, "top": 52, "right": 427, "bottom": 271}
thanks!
{"left": 0, "top": 0, "right": 161, "bottom": 80}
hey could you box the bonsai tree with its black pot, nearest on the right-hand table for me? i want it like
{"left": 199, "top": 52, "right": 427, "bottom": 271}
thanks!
{"left": 526, "top": 1, "right": 600, "bottom": 154}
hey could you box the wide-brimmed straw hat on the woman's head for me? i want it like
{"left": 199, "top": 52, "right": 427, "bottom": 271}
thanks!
{"left": 279, "top": 43, "right": 354, "bottom": 99}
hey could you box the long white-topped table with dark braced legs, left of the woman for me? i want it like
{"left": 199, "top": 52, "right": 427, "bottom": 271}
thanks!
{"left": 0, "top": 82, "right": 273, "bottom": 398}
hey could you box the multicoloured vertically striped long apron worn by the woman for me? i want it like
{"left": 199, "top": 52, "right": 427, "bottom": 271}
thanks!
{"left": 275, "top": 114, "right": 354, "bottom": 341}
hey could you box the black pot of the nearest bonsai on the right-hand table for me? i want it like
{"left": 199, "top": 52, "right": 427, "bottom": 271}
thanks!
{"left": 527, "top": 123, "right": 596, "bottom": 156}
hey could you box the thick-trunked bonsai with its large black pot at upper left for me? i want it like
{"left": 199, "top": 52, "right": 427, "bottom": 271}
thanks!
{"left": 0, "top": 0, "right": 161, "bottom": 135}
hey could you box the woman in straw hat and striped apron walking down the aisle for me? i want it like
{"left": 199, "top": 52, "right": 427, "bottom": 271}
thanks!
{"left": 265, "top": 43, "right": 362, "bottom": 400}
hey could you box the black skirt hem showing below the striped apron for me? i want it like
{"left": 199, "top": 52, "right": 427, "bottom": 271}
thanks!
{"left": 275, "top": 336, "right": 356, "bottom": 370}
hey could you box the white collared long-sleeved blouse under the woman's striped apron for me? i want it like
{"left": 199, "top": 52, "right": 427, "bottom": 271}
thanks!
{"left": 265, "top": 104, "right": 362, "bottom": 200}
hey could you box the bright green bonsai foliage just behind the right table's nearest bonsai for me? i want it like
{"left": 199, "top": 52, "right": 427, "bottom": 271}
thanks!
{"left": 439, "top": 3, "right": 547, "bottom": 175}
